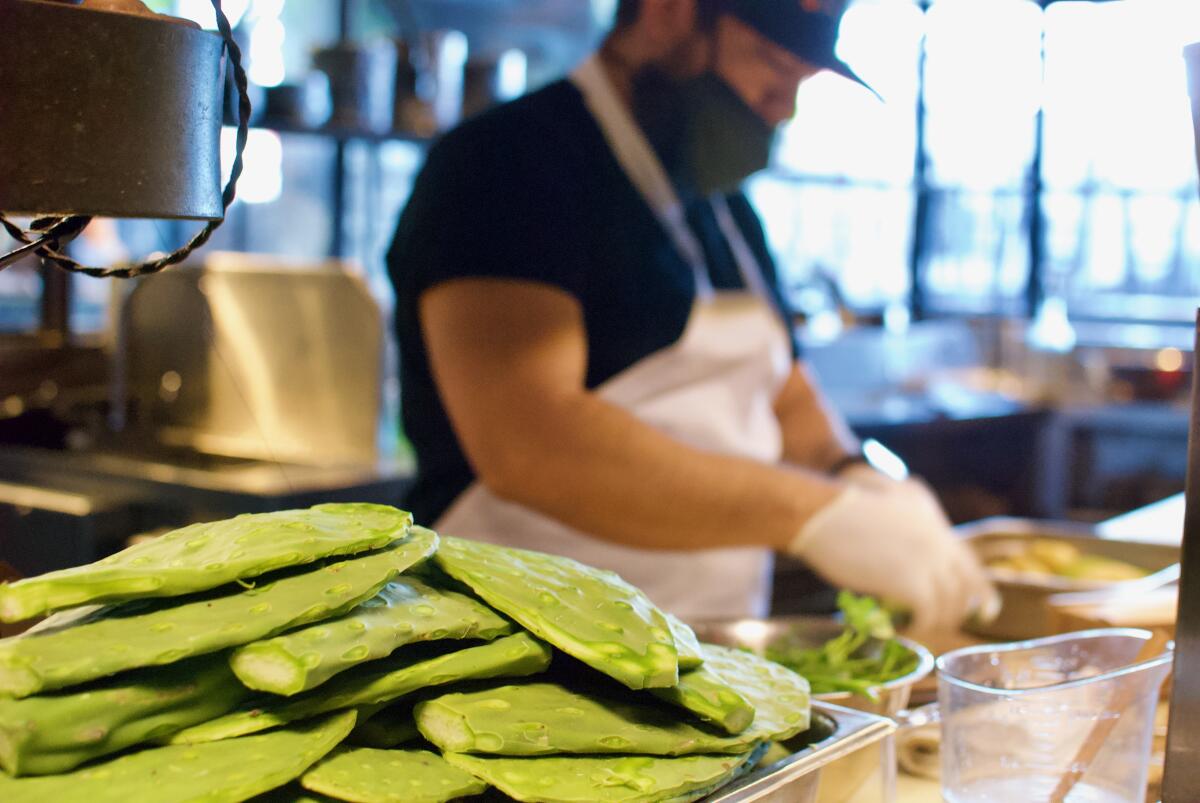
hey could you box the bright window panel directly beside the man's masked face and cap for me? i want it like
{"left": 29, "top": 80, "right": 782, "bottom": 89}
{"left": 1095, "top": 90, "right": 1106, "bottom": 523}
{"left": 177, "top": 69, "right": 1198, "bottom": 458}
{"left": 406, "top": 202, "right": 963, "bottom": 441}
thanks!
{"left": 750, "top": 0, "right": 923, "bottom": 314}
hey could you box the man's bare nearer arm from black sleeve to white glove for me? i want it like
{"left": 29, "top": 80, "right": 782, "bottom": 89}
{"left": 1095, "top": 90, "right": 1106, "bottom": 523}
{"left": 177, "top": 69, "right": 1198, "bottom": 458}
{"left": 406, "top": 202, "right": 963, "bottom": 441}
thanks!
{"left": 420, "top": 278, "right": 841, "bottom": 549}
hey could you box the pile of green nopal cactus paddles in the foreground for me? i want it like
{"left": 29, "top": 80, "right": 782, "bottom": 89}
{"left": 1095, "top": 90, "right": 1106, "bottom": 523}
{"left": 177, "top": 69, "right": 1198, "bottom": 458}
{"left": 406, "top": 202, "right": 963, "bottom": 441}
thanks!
{"left": 0, "top": 504, "right": 809, "bottom": 803}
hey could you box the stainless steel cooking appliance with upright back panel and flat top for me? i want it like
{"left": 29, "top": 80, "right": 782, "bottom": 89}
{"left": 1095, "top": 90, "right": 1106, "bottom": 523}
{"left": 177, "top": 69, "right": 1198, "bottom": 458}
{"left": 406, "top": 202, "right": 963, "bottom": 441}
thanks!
{"left": 0, "top": 254, "right": 409, "bottom": 573}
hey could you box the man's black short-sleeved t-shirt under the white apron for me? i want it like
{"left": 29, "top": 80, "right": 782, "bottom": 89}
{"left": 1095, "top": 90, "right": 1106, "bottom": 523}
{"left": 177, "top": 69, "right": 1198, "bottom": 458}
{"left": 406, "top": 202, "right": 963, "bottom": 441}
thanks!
{"left": 388, "top": 80, "right": 785, "bottom": 523}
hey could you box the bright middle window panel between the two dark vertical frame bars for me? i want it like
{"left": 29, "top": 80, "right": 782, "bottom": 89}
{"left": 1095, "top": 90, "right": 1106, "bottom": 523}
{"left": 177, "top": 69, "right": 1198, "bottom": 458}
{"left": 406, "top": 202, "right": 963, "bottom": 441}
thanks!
{"left": 919, "top": 0, "right": 1042, "bottom": 313}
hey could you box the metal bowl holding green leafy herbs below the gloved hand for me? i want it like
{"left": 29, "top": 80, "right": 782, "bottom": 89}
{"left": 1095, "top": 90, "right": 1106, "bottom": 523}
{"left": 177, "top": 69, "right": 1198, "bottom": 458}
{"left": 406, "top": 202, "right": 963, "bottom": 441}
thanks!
{"left": 692, "top": 616, "right": 934, "bottom": 717}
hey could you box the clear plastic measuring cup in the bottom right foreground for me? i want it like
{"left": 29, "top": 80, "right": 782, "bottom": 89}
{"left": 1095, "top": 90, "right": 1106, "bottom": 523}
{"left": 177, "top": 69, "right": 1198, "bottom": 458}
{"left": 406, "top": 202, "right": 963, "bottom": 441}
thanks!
{"left": 937, "top": 629, "right": 1171, "bottom": 803}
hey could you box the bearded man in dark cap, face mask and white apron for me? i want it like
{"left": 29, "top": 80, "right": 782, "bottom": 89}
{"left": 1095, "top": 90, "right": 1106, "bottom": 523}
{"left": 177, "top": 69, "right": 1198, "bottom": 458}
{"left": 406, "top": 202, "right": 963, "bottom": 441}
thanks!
{"left": 389, "top": 0, "right": 994, "bottom": 628}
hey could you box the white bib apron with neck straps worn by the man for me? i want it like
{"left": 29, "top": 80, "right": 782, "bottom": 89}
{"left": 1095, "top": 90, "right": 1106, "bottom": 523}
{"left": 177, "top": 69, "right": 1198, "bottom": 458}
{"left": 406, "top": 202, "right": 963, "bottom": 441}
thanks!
{"left": 436, "top": 58, "right": 792, "bottom": 622}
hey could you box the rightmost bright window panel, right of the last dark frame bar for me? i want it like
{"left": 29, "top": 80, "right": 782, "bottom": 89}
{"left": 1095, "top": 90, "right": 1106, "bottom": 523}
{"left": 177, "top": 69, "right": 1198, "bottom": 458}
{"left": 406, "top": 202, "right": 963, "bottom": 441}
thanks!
{"left": 1043, "top": 0, "right": 1200, "bottom": 320}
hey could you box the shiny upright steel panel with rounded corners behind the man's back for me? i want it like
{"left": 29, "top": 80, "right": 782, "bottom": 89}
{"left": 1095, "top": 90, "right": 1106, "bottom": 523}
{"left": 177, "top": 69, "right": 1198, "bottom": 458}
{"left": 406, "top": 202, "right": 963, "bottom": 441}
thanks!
{"left": 116, "top": 253, "right": 384, "bottom": 466}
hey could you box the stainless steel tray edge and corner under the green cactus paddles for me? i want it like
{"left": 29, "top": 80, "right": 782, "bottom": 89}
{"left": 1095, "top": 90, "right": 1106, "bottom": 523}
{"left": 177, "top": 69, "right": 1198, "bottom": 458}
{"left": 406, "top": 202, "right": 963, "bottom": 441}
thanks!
{"left": 703, "top": 702, "right": 896, "bottom": 803}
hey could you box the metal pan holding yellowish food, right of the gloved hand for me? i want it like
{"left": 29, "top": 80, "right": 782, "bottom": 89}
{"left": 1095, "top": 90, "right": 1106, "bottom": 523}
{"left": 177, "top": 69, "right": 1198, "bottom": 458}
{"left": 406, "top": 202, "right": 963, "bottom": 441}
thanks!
{"left": 958, "top": 517, "right": 1180, "bottom": 640}
